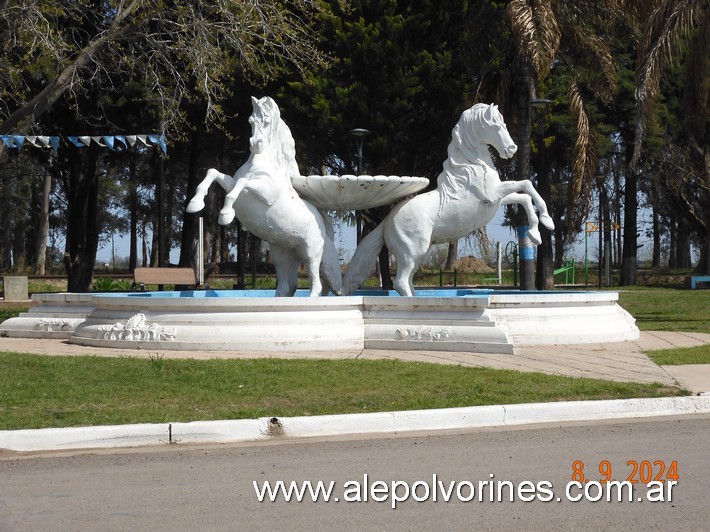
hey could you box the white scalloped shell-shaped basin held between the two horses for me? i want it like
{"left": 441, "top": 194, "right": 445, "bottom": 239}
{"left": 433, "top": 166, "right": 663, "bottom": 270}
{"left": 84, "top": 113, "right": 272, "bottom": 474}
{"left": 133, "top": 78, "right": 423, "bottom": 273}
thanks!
{"left": 291, "top": 175, "right": 429, "bottom": 211}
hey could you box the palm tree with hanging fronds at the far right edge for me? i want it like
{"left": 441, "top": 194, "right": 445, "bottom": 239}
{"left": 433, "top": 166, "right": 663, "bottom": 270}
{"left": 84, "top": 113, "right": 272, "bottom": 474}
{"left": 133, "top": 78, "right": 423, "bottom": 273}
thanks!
{"left": 631, "top": 0, "right": 710, "bottom": 275}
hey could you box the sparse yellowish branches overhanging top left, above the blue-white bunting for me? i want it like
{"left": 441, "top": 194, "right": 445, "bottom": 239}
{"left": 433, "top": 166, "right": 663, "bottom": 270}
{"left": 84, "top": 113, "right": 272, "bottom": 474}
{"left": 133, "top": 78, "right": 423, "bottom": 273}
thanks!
{"left": 0, "top": 0, "right": 324, "bottom": 132}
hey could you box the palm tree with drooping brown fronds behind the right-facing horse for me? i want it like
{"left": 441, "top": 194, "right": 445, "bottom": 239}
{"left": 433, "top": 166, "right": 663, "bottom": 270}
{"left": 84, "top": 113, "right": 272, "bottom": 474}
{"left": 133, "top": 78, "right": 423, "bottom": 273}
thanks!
{"left": 506, "top": 0, "right": 622, "bottom": 289}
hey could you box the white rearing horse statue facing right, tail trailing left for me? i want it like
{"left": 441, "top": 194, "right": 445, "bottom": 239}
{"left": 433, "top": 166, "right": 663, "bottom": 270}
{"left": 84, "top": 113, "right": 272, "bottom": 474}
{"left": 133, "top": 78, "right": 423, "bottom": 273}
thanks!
{"left": 343, "top": 104, "right": 554, "bottom": 296}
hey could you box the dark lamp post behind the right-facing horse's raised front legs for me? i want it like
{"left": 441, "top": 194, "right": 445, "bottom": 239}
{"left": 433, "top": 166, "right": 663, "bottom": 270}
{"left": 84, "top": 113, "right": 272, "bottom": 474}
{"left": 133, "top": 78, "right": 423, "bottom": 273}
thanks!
{"left": 530, "top": 98, "right": 555, "bottom": 290}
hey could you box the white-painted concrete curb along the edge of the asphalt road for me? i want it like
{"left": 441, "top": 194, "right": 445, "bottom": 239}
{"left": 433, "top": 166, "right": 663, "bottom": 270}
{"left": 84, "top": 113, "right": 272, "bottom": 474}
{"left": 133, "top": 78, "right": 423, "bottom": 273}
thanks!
{"left": 0, "top": 395, "right": 710, "bottom": 452}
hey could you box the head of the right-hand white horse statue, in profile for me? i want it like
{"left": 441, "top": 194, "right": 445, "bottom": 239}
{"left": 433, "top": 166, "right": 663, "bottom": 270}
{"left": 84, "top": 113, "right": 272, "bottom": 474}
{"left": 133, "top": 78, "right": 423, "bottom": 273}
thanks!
{"left": 454, "top": 103, "right": 518, "bottom": 159}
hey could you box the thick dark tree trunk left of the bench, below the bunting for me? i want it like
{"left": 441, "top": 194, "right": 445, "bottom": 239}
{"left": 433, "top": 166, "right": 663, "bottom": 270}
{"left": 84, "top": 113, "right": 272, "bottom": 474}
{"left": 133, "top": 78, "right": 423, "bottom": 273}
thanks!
{"left": 64, "top": 147, "right": 99, "bottom": 292}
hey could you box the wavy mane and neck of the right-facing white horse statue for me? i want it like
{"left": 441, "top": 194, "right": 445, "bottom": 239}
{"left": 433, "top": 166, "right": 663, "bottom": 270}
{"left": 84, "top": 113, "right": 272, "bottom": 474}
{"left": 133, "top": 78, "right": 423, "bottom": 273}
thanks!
{"left": 436, "top": 103, "right": 505, "bottom": 211}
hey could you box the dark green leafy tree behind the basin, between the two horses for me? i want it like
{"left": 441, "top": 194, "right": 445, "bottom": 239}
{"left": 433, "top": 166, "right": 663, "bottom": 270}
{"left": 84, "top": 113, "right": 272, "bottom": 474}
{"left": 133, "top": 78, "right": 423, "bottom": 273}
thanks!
{"left": 278, "top": 0, "right": 471, "bottom": 288}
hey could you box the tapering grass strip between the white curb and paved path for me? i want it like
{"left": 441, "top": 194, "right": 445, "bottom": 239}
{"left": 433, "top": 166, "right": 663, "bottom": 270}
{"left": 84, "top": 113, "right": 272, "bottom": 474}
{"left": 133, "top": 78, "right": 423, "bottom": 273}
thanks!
{"left": 0, "top": 352, "right": 689, "bottom": 429}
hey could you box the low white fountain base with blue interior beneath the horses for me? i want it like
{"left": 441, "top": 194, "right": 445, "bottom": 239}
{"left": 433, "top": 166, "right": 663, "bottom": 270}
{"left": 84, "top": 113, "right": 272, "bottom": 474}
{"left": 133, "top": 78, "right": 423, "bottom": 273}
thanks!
{"left": 0, "top": 290, "right": 639, "bottom": 354}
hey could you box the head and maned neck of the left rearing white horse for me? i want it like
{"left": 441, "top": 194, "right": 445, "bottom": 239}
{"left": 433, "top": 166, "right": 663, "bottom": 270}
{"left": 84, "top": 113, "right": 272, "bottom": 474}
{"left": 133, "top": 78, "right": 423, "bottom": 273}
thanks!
{"left": 249, "top": 96, "right": 299, "bottom": 183}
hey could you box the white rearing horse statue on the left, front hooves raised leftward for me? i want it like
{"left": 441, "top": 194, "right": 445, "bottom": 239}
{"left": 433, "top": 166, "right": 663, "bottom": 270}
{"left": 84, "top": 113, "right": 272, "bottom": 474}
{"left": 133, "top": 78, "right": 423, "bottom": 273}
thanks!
{"left": 187, "top": 97, "right": 342, "bottom": 296}
